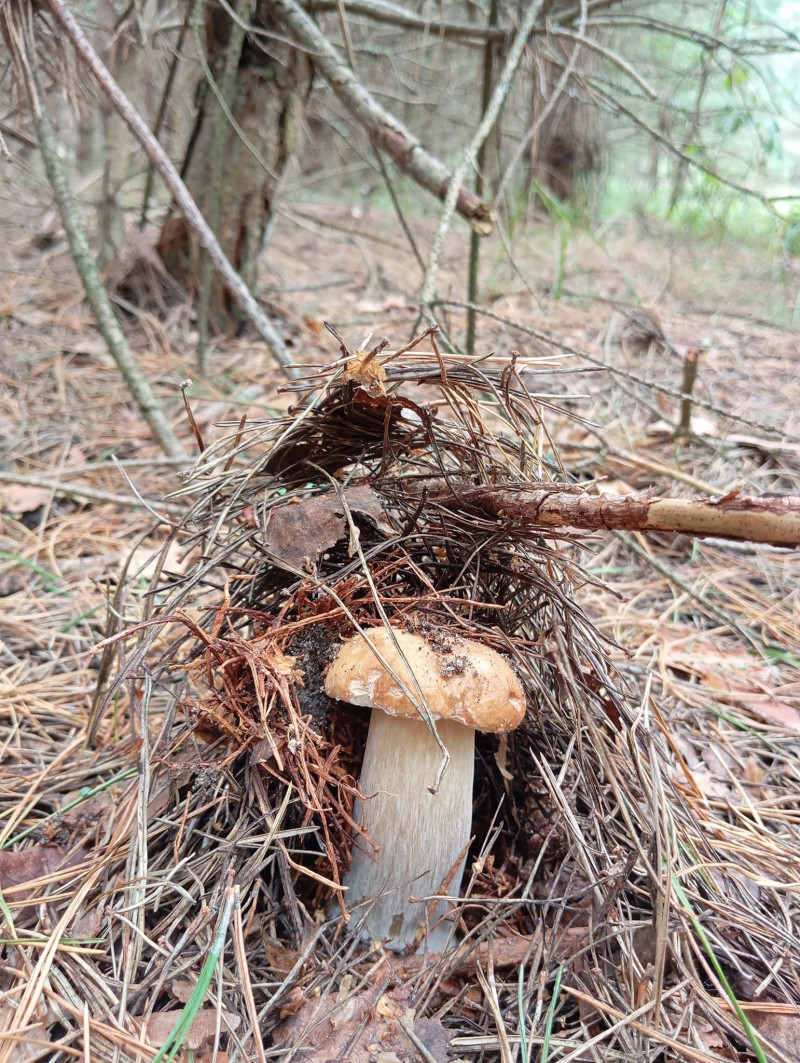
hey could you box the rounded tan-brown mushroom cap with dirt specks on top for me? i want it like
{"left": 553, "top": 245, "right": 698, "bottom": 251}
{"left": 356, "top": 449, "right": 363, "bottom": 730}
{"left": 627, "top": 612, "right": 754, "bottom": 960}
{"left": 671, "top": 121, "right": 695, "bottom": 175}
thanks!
{"left": 325, "top": 627, "right": 525, "bottom": 731}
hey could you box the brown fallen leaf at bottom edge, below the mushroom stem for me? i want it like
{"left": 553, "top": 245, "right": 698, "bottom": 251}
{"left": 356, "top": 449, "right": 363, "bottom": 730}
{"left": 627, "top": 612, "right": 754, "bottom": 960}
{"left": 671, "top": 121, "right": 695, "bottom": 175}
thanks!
{"left": 273, "top": 985, "right": 453, "bottom": 1063}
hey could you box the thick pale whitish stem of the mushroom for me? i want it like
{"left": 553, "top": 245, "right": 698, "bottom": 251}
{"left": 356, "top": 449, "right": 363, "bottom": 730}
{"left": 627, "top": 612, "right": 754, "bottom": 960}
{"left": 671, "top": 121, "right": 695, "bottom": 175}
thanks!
{"left": 344, "top": 709, "right": 475, "bottom": 950}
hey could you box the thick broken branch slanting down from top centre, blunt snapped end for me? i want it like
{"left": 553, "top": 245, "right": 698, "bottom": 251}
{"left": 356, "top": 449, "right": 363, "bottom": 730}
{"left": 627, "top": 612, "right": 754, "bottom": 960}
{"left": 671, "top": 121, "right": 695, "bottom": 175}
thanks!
{"left": 268, "top": 0, "right": 494, "bottom": 236}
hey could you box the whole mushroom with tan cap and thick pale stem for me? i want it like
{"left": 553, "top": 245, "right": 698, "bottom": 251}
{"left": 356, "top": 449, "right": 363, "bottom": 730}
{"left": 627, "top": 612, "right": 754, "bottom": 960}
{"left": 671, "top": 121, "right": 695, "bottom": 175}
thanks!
{"left": 325, "top": 627, "right": 525, "bottom": 950}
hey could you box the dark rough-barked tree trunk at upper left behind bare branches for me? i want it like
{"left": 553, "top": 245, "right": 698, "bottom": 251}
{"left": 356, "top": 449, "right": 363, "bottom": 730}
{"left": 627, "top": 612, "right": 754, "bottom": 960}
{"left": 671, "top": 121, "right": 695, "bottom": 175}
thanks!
{"left": 158, "top": 0, "right": 311, "bottom": 335}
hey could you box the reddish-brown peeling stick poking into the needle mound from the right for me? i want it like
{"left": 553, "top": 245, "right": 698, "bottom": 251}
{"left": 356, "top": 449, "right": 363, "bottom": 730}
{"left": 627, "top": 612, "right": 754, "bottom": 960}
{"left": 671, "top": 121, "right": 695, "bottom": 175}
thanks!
{"left": 439, "top": 487, "right": 800, "bottom": 547}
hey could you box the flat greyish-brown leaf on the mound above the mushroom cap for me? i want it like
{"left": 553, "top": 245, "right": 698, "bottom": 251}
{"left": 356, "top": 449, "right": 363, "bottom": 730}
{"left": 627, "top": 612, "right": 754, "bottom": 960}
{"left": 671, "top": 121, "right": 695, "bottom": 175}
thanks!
{"left": 266, "top": 487, "right": 394, "bottom": 569}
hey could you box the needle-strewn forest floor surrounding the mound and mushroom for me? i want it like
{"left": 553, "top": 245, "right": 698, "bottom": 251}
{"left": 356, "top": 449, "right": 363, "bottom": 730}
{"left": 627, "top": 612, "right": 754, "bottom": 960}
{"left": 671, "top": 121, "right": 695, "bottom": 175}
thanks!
{"left": 0, "top": 182, "right": 800, "bottom": 1063}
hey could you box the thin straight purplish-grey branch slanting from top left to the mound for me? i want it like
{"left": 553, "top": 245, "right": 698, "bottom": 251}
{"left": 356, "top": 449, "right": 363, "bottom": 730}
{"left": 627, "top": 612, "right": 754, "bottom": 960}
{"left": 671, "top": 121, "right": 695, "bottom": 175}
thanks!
{"left": 47, "top": 0, "right": 294, "bottom": 370}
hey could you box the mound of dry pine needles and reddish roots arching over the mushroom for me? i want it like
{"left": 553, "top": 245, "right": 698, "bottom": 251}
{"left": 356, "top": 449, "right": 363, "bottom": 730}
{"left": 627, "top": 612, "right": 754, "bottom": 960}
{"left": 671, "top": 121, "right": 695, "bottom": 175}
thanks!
{"left": 86, "top": 331, "right": 797, "bottom": 1059}
